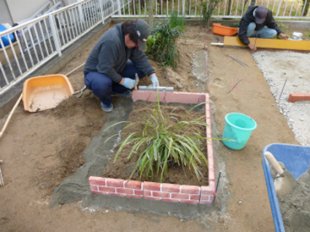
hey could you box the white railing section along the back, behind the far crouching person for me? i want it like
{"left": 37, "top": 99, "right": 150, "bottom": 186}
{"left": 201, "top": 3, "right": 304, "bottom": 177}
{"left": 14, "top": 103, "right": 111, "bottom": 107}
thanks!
{"left": 112, "top": 0, "right": 310, "bottom": 19}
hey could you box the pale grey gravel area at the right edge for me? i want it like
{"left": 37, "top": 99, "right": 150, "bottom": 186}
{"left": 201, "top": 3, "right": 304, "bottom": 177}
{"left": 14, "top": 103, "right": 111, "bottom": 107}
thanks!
{"left": 253, "top": 51, "right": 310, "bottom": 146}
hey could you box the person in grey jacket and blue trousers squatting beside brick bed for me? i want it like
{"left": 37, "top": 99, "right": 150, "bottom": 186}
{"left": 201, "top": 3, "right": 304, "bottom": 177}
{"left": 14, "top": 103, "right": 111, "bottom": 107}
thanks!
{"left": 83, "top": 19, "right": 159, "bottom": 112}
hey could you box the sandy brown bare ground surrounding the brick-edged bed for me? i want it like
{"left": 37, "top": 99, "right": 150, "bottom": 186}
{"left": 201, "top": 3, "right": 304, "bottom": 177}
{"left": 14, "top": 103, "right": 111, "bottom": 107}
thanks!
{"left": 0, "top": 23, "right": 307, "bottom": 232}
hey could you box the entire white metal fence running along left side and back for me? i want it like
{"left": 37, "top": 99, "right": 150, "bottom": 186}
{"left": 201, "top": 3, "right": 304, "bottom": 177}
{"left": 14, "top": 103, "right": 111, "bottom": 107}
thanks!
{"left": 0, "top": 0, "right": 310, "bottom": 95}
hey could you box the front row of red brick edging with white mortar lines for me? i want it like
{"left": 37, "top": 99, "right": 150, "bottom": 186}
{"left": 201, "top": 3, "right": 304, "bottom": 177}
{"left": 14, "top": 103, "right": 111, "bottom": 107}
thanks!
{"left": 88, "top": 176, "right": 214, "bottom": 204}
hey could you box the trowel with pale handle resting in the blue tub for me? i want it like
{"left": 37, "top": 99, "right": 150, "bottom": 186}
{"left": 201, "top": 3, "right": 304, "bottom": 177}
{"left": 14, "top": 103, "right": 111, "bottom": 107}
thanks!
{"left": 264, "top": 151, "right": 296, "bottom": 196}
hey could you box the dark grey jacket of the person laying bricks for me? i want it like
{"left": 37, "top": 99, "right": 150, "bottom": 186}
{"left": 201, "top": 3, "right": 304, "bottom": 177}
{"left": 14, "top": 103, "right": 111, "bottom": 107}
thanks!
{"left": 83, "top": 23, "right": 155, "bottom": 83}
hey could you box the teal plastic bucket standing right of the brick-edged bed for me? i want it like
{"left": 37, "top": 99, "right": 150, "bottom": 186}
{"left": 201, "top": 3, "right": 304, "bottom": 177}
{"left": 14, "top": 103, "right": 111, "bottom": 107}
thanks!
{"left": 223, "top": 113, "right": 257, "bottom": 150}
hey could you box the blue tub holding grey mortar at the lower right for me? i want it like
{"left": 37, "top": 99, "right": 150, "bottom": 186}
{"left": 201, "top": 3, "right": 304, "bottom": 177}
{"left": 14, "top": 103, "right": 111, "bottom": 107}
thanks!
{"left": 262, "top": 143, "right": 310, "bottom": 232}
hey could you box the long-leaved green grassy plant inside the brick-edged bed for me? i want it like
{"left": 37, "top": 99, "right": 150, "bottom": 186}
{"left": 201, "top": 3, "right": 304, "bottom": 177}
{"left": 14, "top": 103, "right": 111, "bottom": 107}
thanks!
{"left": 106, "top": 96, "right": 220, "bottom": 182}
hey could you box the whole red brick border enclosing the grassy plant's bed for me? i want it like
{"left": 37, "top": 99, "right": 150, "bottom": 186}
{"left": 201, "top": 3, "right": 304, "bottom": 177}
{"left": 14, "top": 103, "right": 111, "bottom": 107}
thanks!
{"left": 89, "top": 90, "right": 215, "bottom": 205}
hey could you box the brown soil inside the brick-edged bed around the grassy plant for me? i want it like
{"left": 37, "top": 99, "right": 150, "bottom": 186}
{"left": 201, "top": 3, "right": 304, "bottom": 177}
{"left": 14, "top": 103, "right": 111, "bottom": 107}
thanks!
{"left": 102, "top": 103, "right": 208, "bottom": 186}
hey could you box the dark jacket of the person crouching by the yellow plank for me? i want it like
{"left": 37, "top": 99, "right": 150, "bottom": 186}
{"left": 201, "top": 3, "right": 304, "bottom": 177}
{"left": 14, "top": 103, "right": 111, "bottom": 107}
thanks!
{"left": 238, "top": 6, "right": 281, "bottom": 45}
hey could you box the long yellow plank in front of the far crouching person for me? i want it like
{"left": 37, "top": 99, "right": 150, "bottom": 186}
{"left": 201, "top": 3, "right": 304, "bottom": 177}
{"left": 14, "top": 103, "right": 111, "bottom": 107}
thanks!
{"left": 224, "top": 36, "right": 310, "bottom": 51}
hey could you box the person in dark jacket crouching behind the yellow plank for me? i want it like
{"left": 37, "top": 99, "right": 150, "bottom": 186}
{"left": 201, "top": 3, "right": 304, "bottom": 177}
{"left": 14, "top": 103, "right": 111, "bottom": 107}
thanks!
{"left": 238, "top": 5, "right": 288, "bottom": 51}
